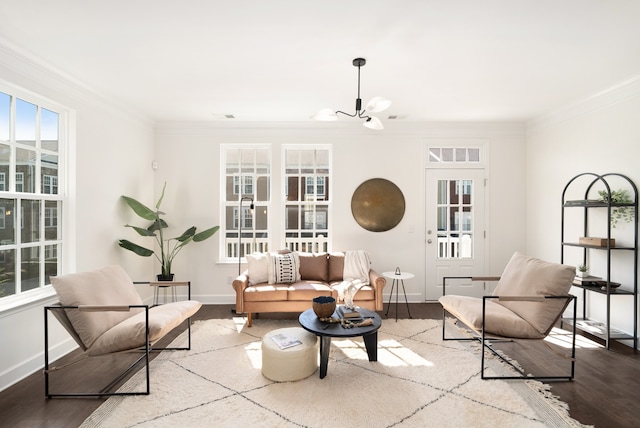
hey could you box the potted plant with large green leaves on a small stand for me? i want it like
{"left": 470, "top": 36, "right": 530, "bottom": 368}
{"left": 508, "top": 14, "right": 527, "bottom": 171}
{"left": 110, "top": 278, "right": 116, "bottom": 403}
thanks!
{"left": 118, "top": 182, "right": 220, "bottom": 281}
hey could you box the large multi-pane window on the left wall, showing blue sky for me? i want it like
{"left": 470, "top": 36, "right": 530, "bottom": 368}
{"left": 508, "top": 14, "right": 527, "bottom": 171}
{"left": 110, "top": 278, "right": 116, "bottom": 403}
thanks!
{"left": 0, "top": 86, "right": 66, "bottom": 299}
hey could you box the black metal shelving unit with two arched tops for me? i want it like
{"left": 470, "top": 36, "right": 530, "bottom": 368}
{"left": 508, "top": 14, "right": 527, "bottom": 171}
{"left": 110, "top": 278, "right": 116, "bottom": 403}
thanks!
{"left": 560, "top": 172, "right": 638, "bottom": 349}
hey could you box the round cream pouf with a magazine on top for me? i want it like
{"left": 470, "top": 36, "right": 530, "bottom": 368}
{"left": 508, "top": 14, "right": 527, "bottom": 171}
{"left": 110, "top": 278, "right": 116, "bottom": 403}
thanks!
{"left": 262, "top": 327, "right": 318, "bottom": 382}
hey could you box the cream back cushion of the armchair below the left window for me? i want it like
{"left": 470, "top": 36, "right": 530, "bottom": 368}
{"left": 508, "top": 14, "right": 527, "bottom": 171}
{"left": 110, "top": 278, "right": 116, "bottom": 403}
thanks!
{"left": 51, "top": 266, "right": 143, "bottom": 348}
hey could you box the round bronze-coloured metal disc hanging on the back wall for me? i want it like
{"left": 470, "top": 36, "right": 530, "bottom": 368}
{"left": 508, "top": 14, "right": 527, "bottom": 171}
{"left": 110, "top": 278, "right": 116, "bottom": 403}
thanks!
{"left": 351, "top": 178, "right": 405, "bottom": 232}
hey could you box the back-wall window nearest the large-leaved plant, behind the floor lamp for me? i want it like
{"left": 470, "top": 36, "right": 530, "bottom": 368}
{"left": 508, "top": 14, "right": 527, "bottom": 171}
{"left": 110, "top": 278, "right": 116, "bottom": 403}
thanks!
{"left": 220, "top": 145, "right": 271, "bottom": 260}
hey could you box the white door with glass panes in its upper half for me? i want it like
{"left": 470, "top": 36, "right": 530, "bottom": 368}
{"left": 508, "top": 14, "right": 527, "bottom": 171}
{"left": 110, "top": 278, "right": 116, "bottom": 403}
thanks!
{"left": 425, "top": 169, "right": 491, "bottom": 301}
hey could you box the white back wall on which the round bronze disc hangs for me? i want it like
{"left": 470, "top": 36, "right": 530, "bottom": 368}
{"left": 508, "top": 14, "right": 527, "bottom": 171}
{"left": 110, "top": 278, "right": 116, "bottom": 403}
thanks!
{"left": 156, "top": 123, "right": 525, "bottom": 303}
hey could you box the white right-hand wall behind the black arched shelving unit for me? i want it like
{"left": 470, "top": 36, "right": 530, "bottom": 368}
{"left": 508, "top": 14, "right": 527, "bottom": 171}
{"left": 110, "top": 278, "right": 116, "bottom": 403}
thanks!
{"left": 526, "top": 78, "right": 640, "bottom": 344}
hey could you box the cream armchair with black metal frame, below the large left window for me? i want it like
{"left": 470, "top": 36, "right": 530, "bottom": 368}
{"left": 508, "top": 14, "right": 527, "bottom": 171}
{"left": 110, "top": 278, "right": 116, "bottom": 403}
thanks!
{"left": 44, "top": 266, "right": 202, "bottom": 398}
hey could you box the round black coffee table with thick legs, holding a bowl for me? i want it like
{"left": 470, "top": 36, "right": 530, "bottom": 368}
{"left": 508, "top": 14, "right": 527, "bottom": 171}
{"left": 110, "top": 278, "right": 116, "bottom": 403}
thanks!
{"left": 298, "top": 308, "right": 382, "bottom": 379}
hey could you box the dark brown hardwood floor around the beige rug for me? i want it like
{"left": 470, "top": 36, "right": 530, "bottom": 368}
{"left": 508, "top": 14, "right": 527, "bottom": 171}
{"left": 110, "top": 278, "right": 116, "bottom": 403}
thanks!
{"left": 0, "top": 303, "right": 640, "bottom": 428}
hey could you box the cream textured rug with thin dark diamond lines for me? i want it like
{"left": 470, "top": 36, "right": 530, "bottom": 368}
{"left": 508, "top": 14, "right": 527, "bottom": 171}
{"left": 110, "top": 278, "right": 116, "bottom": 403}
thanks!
{"left": 82, "top": 318, "right": 592, "bottom": 428}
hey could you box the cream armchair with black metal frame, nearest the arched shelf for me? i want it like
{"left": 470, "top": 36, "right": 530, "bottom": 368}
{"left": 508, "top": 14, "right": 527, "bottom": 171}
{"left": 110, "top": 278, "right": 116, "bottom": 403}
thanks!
{"left": 439, "top": 252, "right": 576, "bottom": 381}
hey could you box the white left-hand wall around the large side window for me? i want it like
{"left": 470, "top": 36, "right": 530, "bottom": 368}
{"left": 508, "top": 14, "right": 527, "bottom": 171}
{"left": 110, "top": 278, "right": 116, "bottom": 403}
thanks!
{"left": 0, "top": 45, "right": 154, "bottom": 390}
